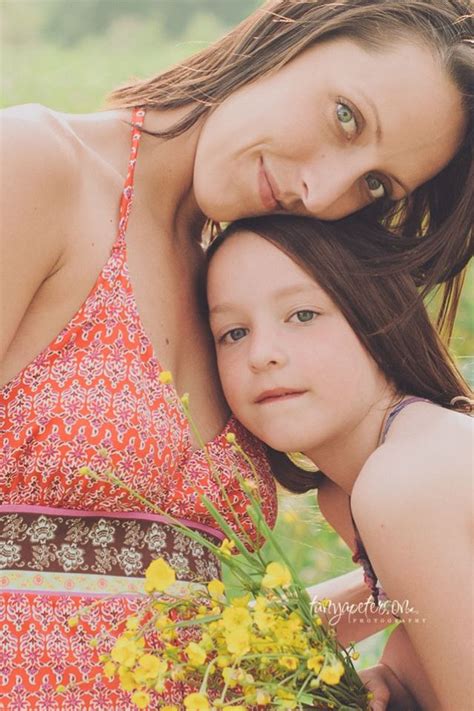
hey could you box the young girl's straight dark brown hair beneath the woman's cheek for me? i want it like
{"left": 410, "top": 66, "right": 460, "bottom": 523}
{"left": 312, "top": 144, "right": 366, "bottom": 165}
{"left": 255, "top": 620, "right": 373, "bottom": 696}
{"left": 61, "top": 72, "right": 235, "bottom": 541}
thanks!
{"left": 208, "top": 215, "right": 471, "bottom": 492}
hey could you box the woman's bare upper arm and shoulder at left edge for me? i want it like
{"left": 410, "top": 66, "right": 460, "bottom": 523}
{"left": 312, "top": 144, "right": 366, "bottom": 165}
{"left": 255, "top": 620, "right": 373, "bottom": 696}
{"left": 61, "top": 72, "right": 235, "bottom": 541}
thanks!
{"left": 0, "top": 106, "right": 72, "bottom": 372}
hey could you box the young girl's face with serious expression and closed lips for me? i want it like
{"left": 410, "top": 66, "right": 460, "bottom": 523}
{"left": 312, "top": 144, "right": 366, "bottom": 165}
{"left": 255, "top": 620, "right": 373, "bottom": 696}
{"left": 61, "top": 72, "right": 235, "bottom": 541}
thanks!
{"left": 208, "top": 232, "right": 388, "bottom": 458}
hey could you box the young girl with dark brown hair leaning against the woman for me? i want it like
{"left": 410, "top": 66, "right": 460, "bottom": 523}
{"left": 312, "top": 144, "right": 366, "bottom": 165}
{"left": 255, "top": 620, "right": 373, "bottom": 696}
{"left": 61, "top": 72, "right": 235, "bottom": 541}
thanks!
{"left": 207, "top": 216, "right": 472, "bottom": 711}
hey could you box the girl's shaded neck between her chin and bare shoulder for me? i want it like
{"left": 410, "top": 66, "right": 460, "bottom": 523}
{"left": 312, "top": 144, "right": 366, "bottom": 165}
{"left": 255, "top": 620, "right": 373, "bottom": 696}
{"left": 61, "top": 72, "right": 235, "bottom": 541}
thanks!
{"left": 305, "top": 393, "right": 400, "bottom": 496}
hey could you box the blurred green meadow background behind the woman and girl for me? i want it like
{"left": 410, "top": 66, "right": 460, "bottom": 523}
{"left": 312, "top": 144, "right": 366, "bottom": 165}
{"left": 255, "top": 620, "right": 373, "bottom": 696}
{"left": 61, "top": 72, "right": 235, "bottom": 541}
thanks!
{"left": 0, "top": 0, "right": 474, "bottom": 666}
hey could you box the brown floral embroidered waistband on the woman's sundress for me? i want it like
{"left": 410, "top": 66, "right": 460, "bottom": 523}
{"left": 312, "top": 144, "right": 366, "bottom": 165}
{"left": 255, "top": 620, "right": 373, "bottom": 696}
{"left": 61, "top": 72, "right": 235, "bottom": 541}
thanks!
{"left": 0, "top": 506, "right": 222, "bottom": 587}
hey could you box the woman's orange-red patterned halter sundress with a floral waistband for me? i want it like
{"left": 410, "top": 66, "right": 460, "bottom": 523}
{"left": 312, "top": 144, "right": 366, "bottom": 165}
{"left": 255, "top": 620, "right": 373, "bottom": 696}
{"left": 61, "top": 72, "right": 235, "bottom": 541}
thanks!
{"left": 0, "top": 109, "right": 276, "bottom": 711}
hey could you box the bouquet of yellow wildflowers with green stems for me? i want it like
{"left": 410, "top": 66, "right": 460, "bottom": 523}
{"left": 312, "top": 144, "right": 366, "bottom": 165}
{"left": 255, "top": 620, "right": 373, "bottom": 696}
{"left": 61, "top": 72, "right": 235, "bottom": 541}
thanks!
{"left": 72, "top": 374, "right": 371, "bottom": 711}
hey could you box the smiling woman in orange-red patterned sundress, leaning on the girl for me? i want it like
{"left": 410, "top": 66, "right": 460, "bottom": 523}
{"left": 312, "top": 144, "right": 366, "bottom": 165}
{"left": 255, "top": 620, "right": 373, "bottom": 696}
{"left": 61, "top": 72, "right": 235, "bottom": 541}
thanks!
{"left": 0, "top": 0, "right": 472, "bottom": 708}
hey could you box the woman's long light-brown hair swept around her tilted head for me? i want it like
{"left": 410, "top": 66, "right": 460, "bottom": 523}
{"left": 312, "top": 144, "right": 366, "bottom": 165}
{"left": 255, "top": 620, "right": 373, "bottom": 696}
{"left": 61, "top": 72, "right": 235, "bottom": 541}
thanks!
{"left": 109, "top": 0, "right": 474, "bottom": 336}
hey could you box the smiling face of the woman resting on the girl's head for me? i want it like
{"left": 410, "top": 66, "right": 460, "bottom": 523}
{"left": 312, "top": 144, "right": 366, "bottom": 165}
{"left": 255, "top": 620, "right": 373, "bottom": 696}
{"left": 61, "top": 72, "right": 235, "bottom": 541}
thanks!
{"left": 194, "top": 39, "right": 465, "bottom": 221}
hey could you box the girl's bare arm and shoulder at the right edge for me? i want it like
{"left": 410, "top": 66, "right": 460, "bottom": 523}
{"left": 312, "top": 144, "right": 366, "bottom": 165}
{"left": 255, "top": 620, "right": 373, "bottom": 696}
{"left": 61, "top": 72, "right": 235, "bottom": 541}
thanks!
{"left": 352, "top": 411, "right": 473, "bottom": 711}
